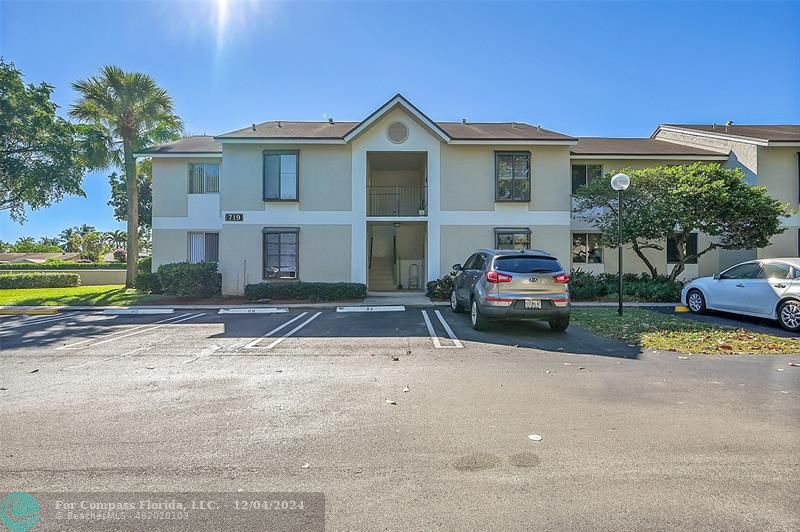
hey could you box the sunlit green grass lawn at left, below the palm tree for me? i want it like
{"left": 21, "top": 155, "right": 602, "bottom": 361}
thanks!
{"left": 0, "top": 285, "right": 163, "bottom": 306}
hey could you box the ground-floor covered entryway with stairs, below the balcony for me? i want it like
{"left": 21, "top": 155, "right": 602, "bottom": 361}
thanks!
{"left": 367, "top": 222, "right": 427, "bottom": 292}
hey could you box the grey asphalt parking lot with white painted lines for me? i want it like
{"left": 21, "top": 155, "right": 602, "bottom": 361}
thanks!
{"left": 0, "top": 307, "right": 800, "bottom": 530}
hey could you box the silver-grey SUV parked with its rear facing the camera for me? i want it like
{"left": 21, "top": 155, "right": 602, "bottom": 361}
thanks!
{"left": 450, "top": 249, "right": 570, "bottom": 331}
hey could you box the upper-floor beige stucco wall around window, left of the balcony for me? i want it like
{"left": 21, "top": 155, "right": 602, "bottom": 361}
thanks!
{"left": 220, "top": 144, "right": 352, "bottom": 211}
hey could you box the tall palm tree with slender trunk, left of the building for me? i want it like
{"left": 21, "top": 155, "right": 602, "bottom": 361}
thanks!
{"left": 70, "top": 66, "right": 183, "bottom": 287}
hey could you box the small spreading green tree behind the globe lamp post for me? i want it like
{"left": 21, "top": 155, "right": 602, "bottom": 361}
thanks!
{"left": 574, "top": 163, "right": 791, "bottom": 280}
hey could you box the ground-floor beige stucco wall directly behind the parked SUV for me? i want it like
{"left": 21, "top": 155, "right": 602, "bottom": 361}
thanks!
{"left": 439, "top": 225, "right": 570, "bottom": 275}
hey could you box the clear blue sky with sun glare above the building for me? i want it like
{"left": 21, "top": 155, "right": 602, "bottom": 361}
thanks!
{"left": 0, "top": 0, "right": 800, "bottom": 241}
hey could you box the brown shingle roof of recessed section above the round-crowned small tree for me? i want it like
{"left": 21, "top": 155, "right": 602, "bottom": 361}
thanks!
{"left": 570, "top": 137, "right": 727, "bottom": 158}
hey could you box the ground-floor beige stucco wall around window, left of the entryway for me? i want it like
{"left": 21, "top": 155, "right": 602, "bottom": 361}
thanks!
{"left": 219, "top": 224, "right": 351, "bottom": 295}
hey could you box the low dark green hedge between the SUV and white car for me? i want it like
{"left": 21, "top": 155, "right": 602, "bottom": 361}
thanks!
{"left": 569, "top": 269, "right": 683, "bottom": 303}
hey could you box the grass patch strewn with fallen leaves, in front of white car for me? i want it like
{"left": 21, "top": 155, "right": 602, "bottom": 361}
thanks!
{"left": 572, "top": 307, "right": 800, "bottom": 354}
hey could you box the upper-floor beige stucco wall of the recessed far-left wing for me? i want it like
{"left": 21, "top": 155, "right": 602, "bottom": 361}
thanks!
{"left": 153, "top": 157, "right": 224, "bottom": 218}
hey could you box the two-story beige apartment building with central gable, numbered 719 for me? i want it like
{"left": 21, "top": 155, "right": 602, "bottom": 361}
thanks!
{"left": 138, "top": 95, "right": 800, "bottom": 294}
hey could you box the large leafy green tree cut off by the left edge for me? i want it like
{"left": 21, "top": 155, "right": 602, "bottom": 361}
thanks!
{"left": 0, "top": 59, "right": 90, "bottom": 222}
